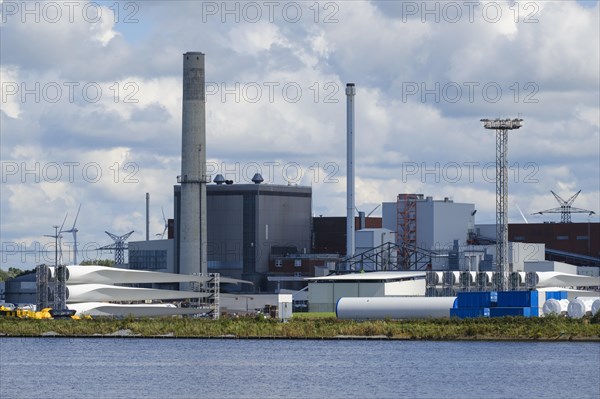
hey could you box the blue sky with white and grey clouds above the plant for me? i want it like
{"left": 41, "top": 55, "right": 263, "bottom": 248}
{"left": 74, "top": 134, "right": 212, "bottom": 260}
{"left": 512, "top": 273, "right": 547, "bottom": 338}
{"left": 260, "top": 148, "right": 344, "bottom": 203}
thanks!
{"left": 0, "top": 0, "right": 600, "bottom": 269}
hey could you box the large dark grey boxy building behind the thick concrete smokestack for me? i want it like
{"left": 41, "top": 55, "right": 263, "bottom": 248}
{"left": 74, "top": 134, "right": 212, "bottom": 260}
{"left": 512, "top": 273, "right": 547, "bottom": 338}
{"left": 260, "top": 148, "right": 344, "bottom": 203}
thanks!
{"left": 173, "top": 182, "right": 312, "bottom": 290}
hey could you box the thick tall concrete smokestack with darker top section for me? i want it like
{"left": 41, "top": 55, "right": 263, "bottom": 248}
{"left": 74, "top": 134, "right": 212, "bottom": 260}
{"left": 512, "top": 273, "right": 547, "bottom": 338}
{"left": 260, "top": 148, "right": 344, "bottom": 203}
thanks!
{"left": 179, "top": 52, "right": 208, "bottom": 289}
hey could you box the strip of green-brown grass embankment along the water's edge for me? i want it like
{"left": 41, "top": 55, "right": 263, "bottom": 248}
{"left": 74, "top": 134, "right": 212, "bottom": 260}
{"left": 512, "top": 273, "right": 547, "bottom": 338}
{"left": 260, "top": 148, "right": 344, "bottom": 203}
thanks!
{"left": 0, "top": 314, "right": 600, "bottom": 341}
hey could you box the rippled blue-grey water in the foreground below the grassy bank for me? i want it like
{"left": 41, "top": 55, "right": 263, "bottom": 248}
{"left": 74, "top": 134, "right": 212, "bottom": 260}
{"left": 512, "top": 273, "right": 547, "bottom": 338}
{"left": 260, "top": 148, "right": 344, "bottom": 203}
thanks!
{"left": 0, "top": 338, "right": 600, "bottom": 399}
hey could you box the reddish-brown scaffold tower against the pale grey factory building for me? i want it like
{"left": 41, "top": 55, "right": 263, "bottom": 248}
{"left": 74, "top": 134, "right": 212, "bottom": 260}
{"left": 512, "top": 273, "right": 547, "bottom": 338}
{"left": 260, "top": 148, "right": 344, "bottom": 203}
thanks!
{"left": 396, "top": 194, "right": 423, "bottom": 270}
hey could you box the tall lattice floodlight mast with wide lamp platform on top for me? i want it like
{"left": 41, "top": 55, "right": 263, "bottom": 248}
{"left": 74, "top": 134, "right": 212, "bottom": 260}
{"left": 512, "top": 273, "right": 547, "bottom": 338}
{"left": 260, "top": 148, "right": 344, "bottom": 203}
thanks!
{"left": 481, "top": 118, "right": 523, "bottom": 291}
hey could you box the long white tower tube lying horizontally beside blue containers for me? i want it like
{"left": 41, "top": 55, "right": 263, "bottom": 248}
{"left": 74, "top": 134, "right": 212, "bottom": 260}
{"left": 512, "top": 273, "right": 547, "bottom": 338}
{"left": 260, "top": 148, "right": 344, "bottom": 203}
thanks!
{"left": 335, "top": 297, "right": 456, "bottom": 320}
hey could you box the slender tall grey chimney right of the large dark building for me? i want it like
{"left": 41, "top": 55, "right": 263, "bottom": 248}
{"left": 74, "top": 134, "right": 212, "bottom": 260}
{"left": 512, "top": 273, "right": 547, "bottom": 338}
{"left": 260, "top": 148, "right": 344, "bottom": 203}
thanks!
{"left": 346, "top": 83, "right": 356, "bottom": 256}
